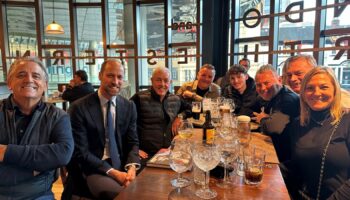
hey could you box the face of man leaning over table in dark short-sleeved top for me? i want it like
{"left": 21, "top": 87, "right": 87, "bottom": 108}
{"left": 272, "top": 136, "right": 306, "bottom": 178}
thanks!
{"left": 255, "top": 71, "right": 282, "bottom": 101}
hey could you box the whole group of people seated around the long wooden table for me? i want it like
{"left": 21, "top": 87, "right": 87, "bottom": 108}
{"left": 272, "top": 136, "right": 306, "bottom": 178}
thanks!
{"left": 0, "top": 55, "right": 350, "bottom": 199}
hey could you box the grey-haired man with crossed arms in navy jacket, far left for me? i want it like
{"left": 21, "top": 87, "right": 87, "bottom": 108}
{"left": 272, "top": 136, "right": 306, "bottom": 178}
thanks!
{"left": 0, "top": 58, "right": 74, "bottom": 199}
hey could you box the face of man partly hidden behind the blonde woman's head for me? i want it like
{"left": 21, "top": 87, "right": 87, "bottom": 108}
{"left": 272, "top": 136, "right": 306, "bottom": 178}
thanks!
{"left": 286, "top": 58, "right": 313, "bottom": 94}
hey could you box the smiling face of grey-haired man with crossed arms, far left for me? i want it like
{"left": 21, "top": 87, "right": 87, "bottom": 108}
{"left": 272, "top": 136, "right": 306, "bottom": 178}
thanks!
{"left": 8, "top": 61, "right": 47, "bottom": 102}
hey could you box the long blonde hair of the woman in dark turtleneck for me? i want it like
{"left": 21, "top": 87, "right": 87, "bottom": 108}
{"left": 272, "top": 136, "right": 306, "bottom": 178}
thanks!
{"left": 300, "top": 66, "right": 342, "bottom": 126}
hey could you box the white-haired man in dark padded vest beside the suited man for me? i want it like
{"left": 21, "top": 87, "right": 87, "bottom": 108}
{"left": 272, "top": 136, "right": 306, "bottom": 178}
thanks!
{"left": 131, "top": 67, "right": 185, "bottom": 167}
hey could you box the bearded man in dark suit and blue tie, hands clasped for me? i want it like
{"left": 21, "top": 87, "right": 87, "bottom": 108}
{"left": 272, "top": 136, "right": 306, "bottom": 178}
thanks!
{"left": 69, "top": 60, "right": 140, "bottom": 199}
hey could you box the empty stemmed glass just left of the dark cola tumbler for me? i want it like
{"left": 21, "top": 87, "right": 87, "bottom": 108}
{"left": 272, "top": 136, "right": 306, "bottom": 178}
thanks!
{"left": 216, "top": 137, "right": 239, "bottom": 188}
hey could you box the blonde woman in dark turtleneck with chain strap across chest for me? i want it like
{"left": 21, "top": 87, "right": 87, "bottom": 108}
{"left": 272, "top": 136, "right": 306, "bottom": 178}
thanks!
{"left": 287, "top": 67, "right": 350, "bottom": 199}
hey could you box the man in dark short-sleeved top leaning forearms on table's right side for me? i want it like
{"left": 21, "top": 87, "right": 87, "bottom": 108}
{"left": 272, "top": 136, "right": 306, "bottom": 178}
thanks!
{"left": 254, "top": 65, "right": 300, "bottom": 162}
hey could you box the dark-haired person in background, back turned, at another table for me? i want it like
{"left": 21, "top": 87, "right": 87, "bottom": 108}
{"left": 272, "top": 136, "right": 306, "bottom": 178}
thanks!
{"left": 62, "top": 70, "right": 94, "bottom": 103}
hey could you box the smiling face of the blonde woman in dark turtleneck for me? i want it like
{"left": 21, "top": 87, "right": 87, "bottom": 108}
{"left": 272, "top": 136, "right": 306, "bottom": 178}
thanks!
{"left": 302, "top": 73, "right": 335, "bottom": 111}
